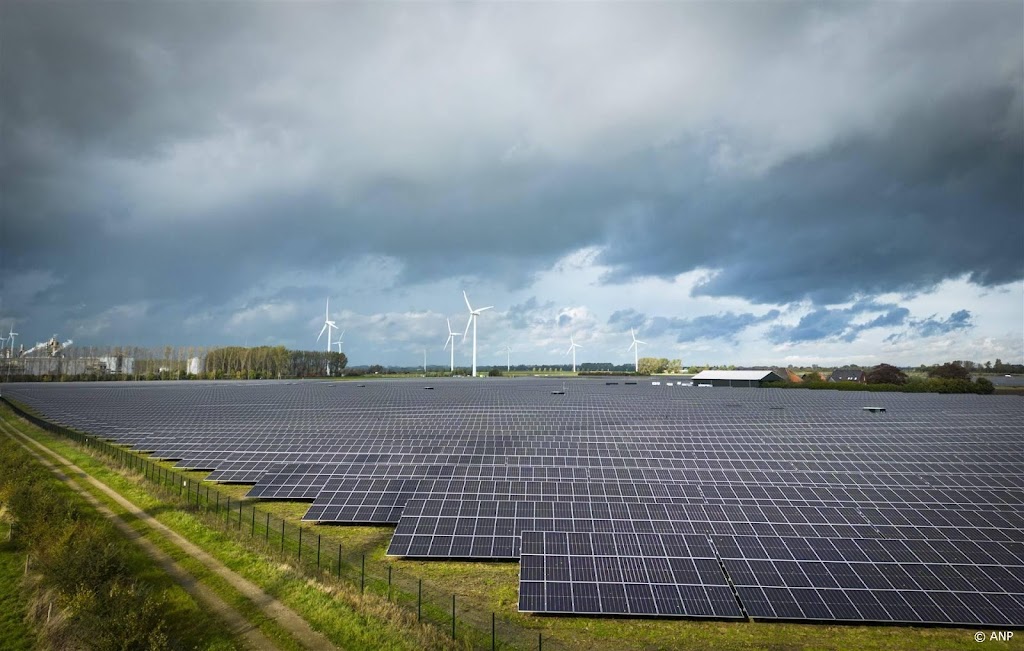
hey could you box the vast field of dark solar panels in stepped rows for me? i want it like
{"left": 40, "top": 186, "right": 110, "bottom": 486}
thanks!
{"left": 4, "top": 379, "right": 1024, "bottom": 626}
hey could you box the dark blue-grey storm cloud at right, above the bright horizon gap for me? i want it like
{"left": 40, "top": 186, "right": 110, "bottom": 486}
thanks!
{"left": 604, "top": 78, "right": 1024, "bottom": 304}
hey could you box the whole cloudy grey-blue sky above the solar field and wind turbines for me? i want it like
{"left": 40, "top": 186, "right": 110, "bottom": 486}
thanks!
{"left": 0, "top": 1, "right": 1024, "bottom": 364}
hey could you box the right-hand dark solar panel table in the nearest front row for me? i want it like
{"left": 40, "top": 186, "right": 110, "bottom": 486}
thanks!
{"left": 712, "top": 536, "right": 1024, "bottom": 626}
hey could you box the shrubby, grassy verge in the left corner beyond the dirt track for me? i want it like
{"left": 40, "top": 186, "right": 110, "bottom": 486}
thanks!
{"left": 0, "top": 429, "right": 242, "bottom": 651}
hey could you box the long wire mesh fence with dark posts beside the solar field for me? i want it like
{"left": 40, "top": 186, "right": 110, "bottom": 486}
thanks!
{"left": 0, "top": 396, "right": 567, "bottom": 651}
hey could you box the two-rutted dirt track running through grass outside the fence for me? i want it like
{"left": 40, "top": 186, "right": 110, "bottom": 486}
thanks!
{"left": 0, "top": 424, "right": 336, "bottom": 649}
